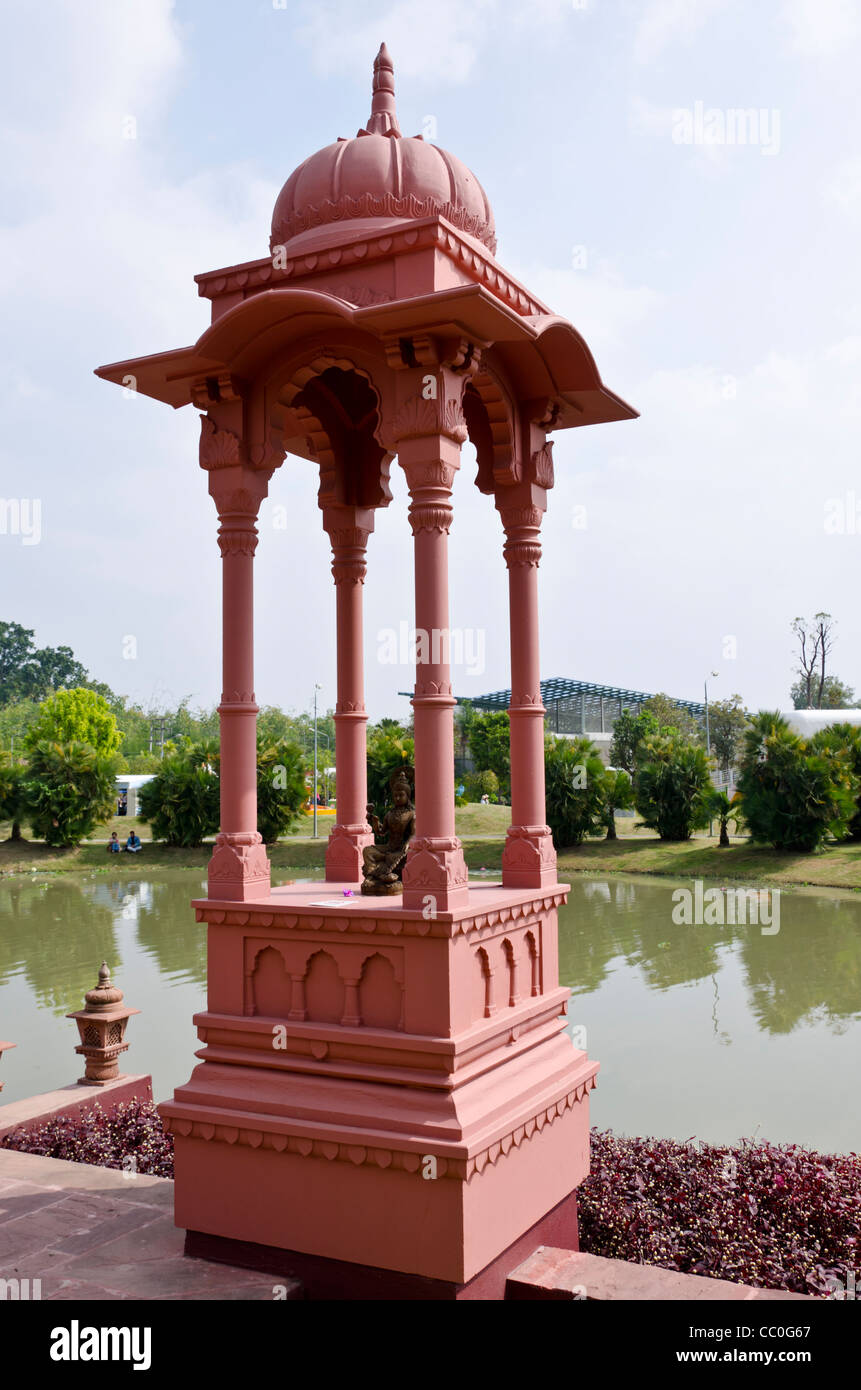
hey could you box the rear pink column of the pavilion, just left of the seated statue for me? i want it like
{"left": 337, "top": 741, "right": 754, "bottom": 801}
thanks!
{"left": 323, "top": 507, "right": 374, "bottom": 883}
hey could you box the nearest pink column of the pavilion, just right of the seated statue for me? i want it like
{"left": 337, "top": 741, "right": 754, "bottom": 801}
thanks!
{"left": 398, "top": 434, "right": 469, "bottom": 916}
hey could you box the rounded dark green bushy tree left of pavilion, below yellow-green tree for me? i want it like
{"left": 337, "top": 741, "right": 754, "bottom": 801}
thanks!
{"left": 24, "top": 739, "right": 115, "bottom": 847}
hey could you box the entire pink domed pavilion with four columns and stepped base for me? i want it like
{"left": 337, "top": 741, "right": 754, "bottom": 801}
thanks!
{"left": 97, "top": 46, "right": 636, "bottom": 1298}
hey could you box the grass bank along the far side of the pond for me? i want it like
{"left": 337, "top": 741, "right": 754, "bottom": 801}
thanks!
{"left": 0, "top": 805, "right": 861, "bottom": 888}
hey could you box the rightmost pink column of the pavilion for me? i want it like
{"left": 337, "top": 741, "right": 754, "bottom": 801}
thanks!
{"left": 501, "top": 506, "right": 556, "bottom": 888}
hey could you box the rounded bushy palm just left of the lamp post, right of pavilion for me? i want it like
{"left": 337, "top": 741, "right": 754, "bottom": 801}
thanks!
{"left": 634, "top": 728, "right": 711, "bottom": 841}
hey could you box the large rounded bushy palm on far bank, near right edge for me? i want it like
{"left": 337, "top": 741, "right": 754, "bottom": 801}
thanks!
{"left": 739, "top": 710, "right": 858, "bottom": 853}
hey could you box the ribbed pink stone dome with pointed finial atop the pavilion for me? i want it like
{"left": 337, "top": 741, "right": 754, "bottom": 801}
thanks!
{"left": 271, "top": 44, "right": 497, "bottom": 253}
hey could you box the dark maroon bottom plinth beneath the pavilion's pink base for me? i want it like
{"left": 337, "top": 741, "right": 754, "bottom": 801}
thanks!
{"left": 185, "top": 1191, "right": 580, "bottom": 1302}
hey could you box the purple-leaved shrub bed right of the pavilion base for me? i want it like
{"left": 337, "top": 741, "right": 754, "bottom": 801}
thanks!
{"left": 577, "top": 1130, "right": 861, "bottom": 1294}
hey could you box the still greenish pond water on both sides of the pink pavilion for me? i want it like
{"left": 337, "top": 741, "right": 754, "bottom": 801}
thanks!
{"left": 0, "top": 870, "right": 861, "bottom": 1151}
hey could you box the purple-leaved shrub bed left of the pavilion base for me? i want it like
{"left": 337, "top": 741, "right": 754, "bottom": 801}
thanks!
{"left": 0, "top": 1101, "right": 174, "bottom": 1177}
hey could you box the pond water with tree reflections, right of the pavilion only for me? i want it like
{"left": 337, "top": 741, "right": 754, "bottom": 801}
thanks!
{"left": 559, "top": 878, "right": 861, "bottom": 1152}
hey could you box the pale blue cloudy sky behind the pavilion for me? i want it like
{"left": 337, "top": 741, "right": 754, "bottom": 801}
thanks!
{"left": 0, "top": 0, "right": 861, "bottom": 719}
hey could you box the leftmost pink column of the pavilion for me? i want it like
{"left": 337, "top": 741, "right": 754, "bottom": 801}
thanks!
{"left": 200, "top": 417, "right": 271, "bottom": 902}
